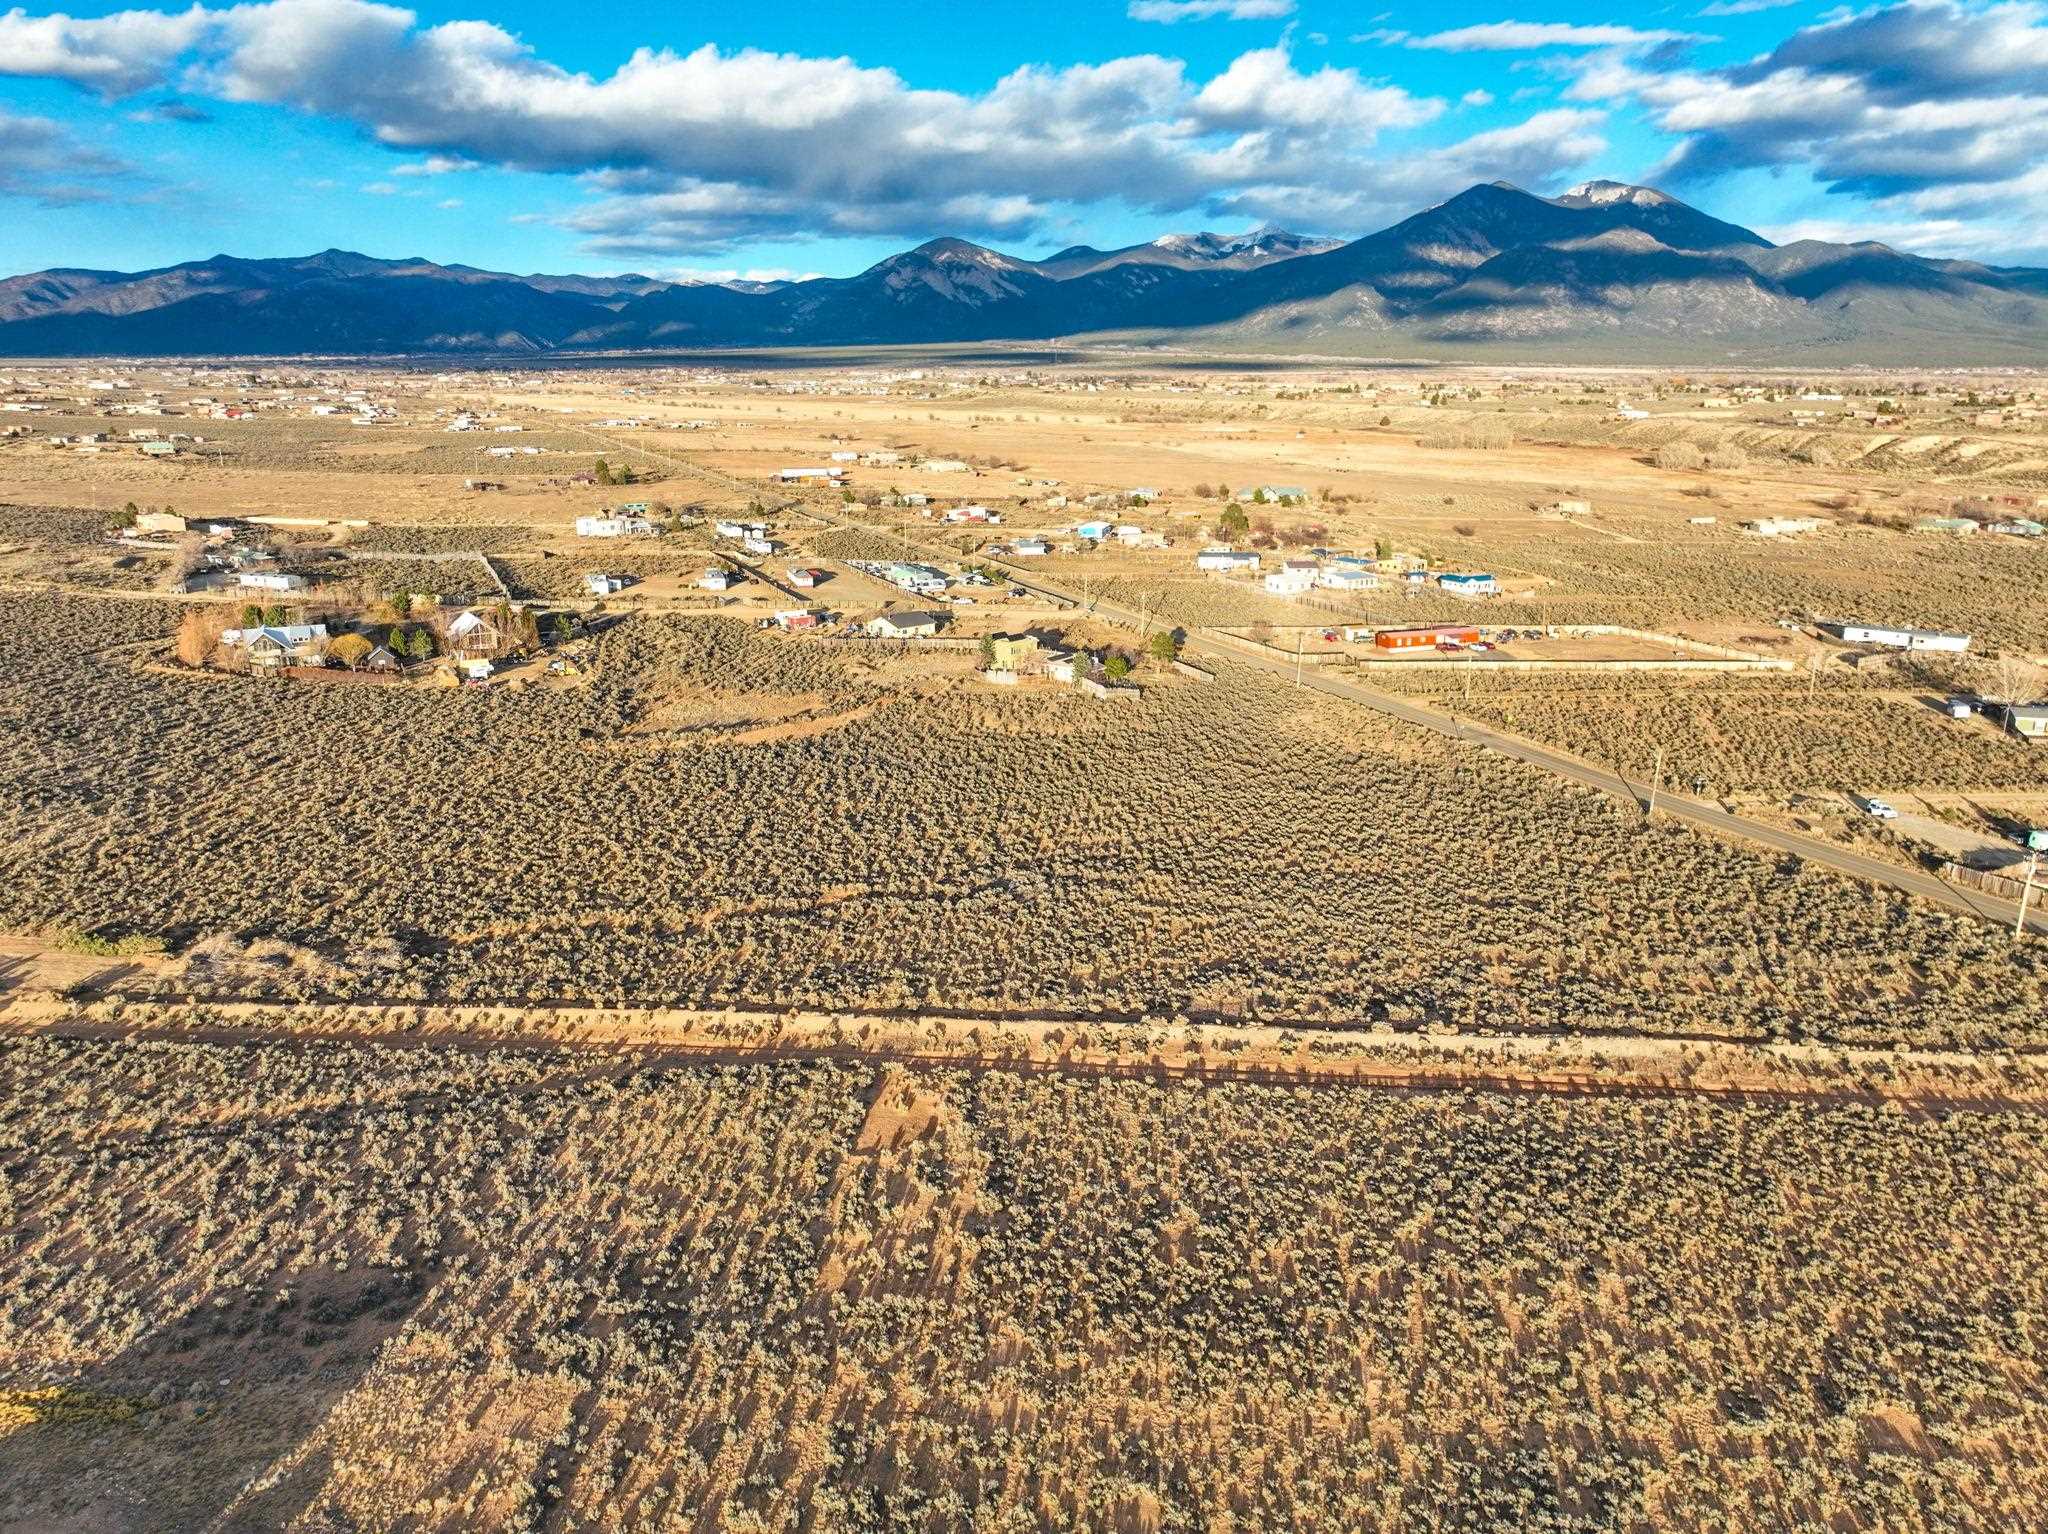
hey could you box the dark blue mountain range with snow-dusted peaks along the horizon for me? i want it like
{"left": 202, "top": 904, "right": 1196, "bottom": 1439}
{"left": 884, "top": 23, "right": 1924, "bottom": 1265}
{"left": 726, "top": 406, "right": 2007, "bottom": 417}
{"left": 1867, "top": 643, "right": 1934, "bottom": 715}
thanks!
{"left": 0, "top": 180, "right": 2048, "bottom": 365}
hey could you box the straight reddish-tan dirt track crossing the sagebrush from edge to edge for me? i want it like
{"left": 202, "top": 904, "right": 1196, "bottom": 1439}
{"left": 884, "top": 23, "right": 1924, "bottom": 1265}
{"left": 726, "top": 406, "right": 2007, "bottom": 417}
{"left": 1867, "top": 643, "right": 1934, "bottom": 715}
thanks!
{"left": 0, "top": 999, "right": 2048, "bottom": 1116}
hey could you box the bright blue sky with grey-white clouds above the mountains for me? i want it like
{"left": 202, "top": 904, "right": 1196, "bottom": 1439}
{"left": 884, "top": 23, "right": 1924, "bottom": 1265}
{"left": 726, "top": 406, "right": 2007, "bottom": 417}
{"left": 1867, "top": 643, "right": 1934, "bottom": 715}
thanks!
{"left": 0, "top": 0, "right": 2048, "bottom": 274}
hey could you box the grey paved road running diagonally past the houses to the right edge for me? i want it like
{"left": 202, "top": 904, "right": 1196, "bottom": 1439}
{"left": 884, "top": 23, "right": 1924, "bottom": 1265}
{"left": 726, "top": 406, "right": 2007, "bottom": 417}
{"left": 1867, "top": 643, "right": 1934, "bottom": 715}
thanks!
{"left": 798, "top": 501, "right": 2048, "bottom": 936}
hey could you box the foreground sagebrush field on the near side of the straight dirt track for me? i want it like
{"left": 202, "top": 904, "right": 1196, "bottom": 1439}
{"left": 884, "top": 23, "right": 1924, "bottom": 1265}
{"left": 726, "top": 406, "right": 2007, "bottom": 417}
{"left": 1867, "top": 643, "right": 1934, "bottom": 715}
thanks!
{"left": 0, "top": 1038, "right": 2048, "bottom": 1534}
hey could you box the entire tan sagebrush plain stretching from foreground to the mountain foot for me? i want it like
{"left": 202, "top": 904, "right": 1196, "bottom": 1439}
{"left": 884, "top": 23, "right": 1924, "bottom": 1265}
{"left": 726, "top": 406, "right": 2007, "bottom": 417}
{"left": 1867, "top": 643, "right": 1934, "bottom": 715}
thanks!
{"left": 0, "top": 354, "right": 2048, "bottom": 1534}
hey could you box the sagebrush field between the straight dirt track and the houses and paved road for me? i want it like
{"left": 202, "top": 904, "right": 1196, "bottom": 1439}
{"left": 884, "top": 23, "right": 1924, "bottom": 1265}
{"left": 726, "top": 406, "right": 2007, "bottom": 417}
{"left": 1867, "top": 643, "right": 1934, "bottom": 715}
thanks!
{"left": 0, "top": 596, "right": 2048, "bottom": 1040}
